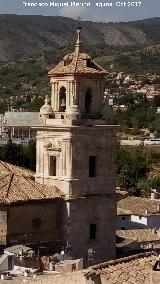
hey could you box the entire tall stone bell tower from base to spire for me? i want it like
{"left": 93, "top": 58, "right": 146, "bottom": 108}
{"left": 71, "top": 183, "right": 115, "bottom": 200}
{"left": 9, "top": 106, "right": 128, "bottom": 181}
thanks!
{"left": 36, "top": 29, "right": 116, "bottom": 262}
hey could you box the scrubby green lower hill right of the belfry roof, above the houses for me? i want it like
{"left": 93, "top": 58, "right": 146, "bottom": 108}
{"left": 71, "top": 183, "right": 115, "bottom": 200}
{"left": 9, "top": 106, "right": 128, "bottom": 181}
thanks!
{"left": 95, "top": 44, "right": 160, "bottom": 75}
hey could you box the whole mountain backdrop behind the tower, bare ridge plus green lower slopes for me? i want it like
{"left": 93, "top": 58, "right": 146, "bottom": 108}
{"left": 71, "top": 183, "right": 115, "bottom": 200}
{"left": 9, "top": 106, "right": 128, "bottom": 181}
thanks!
{"left": 0, "top": 15, "right": 160, "bottom": 112}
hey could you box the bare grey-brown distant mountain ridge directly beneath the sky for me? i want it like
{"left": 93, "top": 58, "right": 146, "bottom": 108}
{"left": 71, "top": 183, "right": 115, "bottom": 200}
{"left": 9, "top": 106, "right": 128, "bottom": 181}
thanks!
{"left": 0, "top": 15, "right": 160, "bottom": 61}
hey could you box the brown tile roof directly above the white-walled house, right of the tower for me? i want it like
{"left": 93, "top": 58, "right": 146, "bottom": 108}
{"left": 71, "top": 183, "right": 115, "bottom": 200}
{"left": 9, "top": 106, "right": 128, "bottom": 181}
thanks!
{"left": 117, "top": 197, "right": 160, "bottom": 216}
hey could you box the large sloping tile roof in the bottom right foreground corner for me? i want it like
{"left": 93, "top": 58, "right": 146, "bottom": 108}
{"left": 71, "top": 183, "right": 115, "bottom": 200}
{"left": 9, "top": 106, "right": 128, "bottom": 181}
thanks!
{"left": 85, "top": 252, "right": 157, "bottom": 284}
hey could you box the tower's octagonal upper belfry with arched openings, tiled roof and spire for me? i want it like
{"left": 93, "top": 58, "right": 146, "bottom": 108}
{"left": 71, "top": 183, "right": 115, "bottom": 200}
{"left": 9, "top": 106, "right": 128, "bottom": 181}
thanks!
{"left": 49, "top": 29, "right": 107, "bottom": 118}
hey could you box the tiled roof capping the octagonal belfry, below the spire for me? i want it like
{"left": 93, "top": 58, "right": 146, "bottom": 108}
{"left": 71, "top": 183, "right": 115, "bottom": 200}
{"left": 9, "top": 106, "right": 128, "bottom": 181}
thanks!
{"left": 48, "top": 52, "right": 108, "bottom": 76}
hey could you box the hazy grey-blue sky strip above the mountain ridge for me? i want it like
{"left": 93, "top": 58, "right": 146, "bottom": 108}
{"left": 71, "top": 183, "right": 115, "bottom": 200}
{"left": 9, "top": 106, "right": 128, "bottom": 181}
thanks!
{"left": 0, "top": 0, "right": 160, "bottom": 22}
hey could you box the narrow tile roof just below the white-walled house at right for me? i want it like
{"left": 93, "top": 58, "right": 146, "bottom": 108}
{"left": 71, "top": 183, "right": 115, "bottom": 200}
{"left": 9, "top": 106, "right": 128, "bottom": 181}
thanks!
{"left": 117, "top": 229, "right": 160, "bottom": 242}
